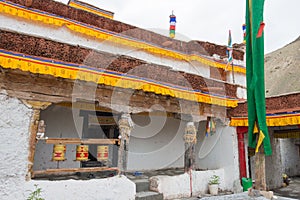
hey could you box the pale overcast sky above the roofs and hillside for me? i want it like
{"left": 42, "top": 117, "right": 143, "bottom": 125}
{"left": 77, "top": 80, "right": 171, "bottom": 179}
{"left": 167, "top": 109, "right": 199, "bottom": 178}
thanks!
{"left": 58, "top": 0, "right": 300, "bottom": 53}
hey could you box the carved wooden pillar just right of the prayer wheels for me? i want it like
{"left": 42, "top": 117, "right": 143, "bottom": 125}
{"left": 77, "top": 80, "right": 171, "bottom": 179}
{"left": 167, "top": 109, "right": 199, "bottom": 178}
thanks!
{"left": 118, "top": 114, "right": 133, "bottom": 174}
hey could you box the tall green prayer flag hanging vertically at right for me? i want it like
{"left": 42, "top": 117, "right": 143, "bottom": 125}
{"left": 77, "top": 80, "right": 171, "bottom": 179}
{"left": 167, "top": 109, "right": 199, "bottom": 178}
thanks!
{"left": 246, "top": 0, "right": 272, "bottom": 155}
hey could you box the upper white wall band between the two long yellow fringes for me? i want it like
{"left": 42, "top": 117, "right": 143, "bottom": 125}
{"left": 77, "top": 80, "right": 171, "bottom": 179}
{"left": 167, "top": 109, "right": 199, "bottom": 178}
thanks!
{"left": 0, "top": 14, "right": 237, "bottom": 81}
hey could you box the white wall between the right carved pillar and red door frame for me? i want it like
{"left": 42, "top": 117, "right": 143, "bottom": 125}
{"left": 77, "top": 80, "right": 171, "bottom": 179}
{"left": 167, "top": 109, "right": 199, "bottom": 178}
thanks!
{"left": 196, "top": 121, "right": 239, "bottom": 190}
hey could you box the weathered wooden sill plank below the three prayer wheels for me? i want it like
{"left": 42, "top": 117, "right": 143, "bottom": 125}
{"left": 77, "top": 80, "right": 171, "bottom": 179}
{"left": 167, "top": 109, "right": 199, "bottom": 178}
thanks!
{"left": 33, "top": 167, "right": 119, "bottom": 176}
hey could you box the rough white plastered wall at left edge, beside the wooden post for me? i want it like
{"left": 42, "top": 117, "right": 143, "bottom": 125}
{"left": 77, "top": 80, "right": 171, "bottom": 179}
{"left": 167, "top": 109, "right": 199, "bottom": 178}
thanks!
{"left": 0, "top": 91, "right": 32, "bottom": 199}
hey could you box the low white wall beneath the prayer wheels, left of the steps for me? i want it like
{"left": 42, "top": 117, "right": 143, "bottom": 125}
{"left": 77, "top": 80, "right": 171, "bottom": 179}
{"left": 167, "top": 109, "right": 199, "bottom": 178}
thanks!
{"left": 23, "top": 176, "right": 136, "bottom": 200}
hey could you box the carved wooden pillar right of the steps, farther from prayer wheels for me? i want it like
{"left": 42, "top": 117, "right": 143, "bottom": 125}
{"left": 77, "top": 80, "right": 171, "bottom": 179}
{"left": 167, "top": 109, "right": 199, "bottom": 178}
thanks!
{"left": 184, "top": 122, "right": 197, "bottom": 172}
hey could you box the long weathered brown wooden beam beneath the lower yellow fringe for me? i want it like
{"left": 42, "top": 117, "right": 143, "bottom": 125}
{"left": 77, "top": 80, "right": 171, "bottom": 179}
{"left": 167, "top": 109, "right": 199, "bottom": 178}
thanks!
{"left": 0, "top": 69, "right": 224, "bottom": 116}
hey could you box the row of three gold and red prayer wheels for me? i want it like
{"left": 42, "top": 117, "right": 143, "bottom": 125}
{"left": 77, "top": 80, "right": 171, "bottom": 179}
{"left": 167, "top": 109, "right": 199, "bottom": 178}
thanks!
{"left": 52, "top": 144, "right": 108, "bottom": 161}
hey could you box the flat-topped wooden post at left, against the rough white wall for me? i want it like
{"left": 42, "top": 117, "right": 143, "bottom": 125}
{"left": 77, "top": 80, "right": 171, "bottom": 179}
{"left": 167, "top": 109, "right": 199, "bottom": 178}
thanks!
{"left": 24, "top": 101, "right": 51, "bottom": 180}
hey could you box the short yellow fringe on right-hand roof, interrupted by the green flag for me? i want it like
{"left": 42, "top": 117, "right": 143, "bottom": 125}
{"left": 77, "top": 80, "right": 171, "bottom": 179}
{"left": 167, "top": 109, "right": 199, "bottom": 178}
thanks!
{"left": 230, "top": 113, "right": 300, "bottom": 126}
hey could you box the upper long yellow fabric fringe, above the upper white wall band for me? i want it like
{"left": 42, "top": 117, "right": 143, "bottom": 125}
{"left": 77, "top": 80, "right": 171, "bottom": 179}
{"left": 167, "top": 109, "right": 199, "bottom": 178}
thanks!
{"left": 0, "top": 2, "right": 246, "bottom": 74}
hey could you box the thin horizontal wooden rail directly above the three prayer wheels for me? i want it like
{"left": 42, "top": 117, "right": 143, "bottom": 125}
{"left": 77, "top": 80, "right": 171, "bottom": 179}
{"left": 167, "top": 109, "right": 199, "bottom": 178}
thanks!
{"left": 46, "top": 138, "right": 120, "bottom": 144}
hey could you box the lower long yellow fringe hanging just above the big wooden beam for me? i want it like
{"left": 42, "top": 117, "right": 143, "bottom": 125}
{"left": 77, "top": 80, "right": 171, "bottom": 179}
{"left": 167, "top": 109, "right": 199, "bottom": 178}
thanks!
{"left": 0, "top": 50, "right": 238, "bottom": 107}
